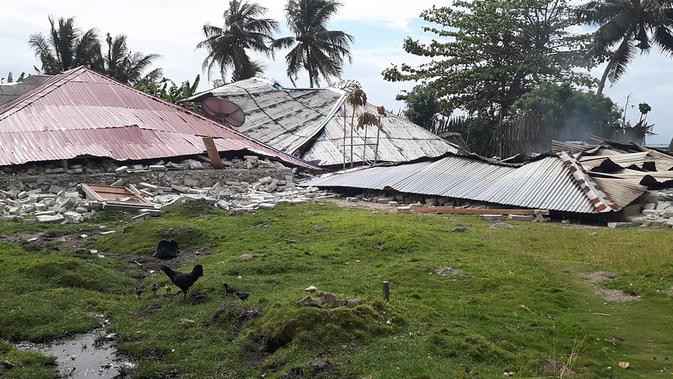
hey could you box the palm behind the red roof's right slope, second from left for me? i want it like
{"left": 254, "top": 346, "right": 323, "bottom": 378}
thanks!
{"left": 104, "top": 33, "right": 160, "bottom": 84}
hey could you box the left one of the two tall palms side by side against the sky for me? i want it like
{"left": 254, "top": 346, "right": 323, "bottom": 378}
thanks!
{"left": 196, "top": 0, "right": 278, "bottom": 80}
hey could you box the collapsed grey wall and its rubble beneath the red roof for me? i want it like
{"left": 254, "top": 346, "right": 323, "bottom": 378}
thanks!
{"left": 0, "top": 155, "right": 332, "bottom": 223}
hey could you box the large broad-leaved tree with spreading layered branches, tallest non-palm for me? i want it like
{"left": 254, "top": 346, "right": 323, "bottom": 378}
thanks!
{"left": 383, "top": 0, "right": 590, "bottom": 124}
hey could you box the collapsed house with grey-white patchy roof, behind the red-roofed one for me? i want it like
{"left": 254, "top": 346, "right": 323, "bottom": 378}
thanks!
{"left": 188, "top": 78, "right": 460, "bottom": 168}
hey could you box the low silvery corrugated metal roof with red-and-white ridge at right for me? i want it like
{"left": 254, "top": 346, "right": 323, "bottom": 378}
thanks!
{"left": 302, "top": 153, "right": 645, "bottom": 213}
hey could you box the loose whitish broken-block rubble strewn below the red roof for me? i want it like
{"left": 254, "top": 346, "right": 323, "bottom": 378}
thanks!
{"left": 0, "top": 175, "right": 335, "bottom": 224}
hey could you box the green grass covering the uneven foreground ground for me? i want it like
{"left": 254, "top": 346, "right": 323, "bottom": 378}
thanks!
{"left": 0, "top": 205, "right": 673, "bottom": 378}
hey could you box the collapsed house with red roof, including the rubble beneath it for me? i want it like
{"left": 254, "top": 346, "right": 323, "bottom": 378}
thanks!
{"left": 0, "top": 67, "right": 330, "bottom": 222}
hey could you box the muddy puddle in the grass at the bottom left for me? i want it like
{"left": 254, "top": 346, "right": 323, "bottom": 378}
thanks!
{"left": 17, "top": 328, "right": 133, "bottom": 379}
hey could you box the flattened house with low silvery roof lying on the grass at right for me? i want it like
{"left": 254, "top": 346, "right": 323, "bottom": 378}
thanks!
{"left": 302, "top": 153, "right": 647, "bottom": 220}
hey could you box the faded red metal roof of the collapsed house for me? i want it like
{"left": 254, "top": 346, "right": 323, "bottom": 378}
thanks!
{"left": 0, "top": 67, "right": 317, "bottom": 169}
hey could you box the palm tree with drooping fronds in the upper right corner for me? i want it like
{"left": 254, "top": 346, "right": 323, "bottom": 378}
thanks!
{"left": 580, "top": 0, "right": 673, "bottom": 94}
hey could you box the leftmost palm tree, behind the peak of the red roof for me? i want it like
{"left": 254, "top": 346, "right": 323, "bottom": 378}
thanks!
{"left": 28, "top": 17, "right": 103, "bottom": 75}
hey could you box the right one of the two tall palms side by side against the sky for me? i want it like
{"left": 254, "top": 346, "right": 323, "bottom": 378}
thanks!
{"left": 273, "top": 0, "right": 353, "bottom": 88}
